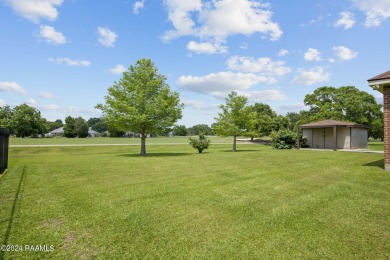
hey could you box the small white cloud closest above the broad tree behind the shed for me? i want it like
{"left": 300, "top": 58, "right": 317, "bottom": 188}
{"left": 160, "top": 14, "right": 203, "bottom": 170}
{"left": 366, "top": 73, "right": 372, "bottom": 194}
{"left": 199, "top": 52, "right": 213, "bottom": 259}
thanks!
{"left": 291, "top": 66, "right": 330, "bottom": 86}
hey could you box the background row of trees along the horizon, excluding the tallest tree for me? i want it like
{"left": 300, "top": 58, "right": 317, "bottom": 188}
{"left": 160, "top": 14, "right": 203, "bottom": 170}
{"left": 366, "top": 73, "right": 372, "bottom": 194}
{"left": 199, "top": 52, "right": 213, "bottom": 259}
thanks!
{"left": 0, "top": 86, "right": 383, "bottom": 139}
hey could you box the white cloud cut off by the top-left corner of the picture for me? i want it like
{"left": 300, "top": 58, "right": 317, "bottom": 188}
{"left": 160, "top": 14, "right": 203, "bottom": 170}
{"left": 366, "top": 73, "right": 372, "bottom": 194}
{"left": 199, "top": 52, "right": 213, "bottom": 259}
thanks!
{"left": 5, "top": 0, "right": 63, "bottom": 23}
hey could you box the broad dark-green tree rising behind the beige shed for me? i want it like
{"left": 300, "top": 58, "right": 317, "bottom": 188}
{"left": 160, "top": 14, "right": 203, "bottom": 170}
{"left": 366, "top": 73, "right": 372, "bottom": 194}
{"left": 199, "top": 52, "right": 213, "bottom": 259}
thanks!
{"left": 304, "top": 86, "right": 383, "bottom": 137}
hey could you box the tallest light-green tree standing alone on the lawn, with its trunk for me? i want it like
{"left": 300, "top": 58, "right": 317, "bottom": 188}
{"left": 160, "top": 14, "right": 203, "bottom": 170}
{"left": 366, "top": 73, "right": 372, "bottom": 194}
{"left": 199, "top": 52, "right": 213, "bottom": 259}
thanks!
{"left": 96, "top": 59, "right": 183, "bottom": 156}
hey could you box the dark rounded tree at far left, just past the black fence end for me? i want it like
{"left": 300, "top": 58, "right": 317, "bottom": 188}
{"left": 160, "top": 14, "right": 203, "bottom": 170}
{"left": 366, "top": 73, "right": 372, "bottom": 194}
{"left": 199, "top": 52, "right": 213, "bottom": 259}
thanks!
{"left": 9, "top": 104, "right": 48, "bottom": 137}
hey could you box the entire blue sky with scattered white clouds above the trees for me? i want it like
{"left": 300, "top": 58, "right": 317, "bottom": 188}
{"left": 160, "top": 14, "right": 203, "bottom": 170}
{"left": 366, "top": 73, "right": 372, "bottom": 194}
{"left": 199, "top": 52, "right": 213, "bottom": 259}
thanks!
{"left": 0, "top": 0, "right": 390, "bottom": 126}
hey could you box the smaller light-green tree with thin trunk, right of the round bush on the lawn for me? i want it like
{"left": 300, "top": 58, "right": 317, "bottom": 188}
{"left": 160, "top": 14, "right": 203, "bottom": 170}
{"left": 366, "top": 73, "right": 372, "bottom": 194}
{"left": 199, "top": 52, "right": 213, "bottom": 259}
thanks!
{"left": 213, "top": 91, "right": 256, "bottom": 152}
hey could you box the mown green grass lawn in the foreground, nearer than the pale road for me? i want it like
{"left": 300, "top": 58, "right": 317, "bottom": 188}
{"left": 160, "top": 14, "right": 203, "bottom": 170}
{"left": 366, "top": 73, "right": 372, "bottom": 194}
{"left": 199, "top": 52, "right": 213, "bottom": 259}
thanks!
{"left": 0, "top": 145, "right": 390, "bottom": 259}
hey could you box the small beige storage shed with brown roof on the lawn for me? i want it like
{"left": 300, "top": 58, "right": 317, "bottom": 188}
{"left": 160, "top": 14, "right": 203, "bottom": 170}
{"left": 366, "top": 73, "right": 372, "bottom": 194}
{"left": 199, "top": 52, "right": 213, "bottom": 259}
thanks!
{"left": 298, "top": 120, "right": 369, "bottom": 150}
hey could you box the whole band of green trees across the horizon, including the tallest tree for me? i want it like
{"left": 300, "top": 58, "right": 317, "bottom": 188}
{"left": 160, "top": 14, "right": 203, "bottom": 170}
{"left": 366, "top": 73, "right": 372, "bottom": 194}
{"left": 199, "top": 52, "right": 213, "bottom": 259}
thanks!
{"left": 0, "top": 59, "right": 383, "bottom": 150}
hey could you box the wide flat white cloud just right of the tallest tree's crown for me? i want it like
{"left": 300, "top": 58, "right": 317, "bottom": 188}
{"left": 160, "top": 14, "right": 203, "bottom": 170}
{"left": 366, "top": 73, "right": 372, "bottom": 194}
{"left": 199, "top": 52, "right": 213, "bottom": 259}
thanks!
{"left": 177, "top": 72, "right": 269, "bottom": 98}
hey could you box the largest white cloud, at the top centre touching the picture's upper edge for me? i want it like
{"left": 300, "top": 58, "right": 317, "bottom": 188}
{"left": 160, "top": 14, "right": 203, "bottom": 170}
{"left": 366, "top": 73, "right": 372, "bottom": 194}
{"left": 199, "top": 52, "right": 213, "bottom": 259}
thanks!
{"left": 163, "top": 0, "right": 283, "bottom": 42}
